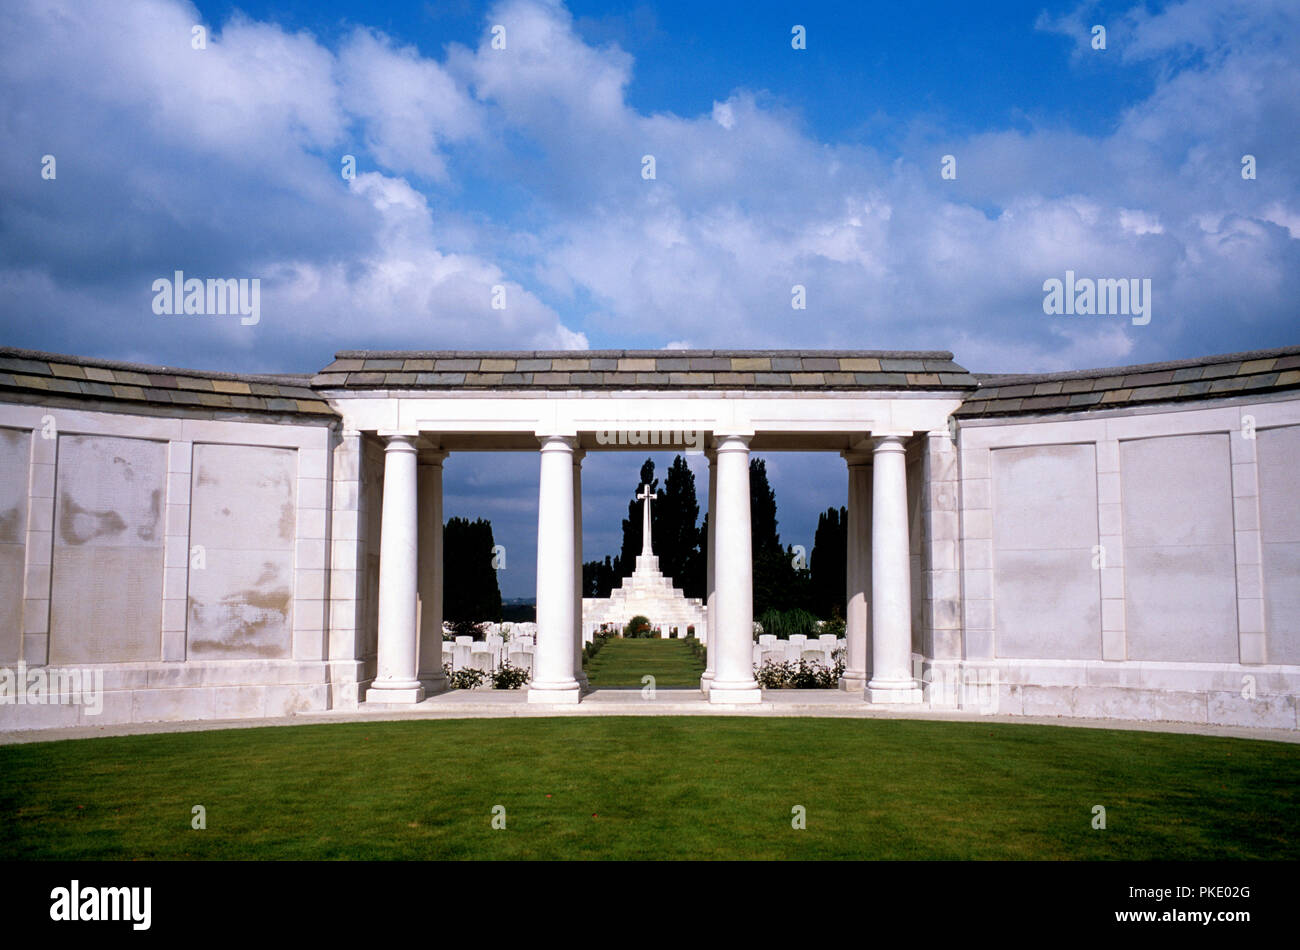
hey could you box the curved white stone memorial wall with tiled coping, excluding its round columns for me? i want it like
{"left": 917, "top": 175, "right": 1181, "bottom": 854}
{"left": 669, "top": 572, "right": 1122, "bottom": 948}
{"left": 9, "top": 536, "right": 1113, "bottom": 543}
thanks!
{"left": 0, "top": 347, "right": 1300, "bottom": 729}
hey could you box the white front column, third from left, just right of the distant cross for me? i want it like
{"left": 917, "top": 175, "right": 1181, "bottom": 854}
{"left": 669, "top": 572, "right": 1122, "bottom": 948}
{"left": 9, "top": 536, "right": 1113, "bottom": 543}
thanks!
{"left": 709, "top": 435, "right": 763, "bottom": 703}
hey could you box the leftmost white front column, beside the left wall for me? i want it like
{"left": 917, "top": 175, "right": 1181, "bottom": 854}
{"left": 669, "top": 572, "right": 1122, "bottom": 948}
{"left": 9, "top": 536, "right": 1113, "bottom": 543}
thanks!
{"left": 365, "top": 435, "right": 424, "bottom": 703}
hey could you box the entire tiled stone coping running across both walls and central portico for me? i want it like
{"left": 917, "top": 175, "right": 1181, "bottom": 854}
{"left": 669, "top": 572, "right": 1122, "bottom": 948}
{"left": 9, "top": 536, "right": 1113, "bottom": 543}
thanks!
{"left": 0, "top": 346, "right": 1300, "bottom": 418}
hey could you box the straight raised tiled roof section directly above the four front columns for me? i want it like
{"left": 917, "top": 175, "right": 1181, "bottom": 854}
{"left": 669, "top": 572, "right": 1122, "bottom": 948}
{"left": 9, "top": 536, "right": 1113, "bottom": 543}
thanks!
{"left": 312, "top": 350, "right": 976, "bottom": 391}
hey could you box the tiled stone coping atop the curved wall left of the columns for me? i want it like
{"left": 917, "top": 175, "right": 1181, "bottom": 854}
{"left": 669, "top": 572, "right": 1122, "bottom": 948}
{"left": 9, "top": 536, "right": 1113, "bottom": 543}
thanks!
{"left": 0, "top": 347, "right": 338, "bottom": 417}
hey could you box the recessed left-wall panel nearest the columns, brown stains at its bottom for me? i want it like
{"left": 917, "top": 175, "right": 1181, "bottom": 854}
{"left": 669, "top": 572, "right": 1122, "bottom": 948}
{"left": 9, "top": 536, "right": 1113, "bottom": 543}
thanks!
{"left": 187, "top": 444, "right": 298, "bottom": 659}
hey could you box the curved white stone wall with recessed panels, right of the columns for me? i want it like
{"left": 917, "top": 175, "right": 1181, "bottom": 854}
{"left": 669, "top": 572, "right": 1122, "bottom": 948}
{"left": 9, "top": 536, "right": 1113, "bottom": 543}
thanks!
{"left": 951, "top": 396, "right": 1300, "bottom": 728}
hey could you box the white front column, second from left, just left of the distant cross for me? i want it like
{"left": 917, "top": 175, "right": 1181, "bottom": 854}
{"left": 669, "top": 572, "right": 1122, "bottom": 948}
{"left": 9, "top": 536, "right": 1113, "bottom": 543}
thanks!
{"left": 528, "top": 435, "right": 581, "bottom": 703}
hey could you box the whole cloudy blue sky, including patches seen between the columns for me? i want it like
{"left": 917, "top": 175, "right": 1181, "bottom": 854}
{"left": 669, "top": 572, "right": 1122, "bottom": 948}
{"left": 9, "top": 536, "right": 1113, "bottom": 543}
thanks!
{"left": 0, "top": 0, "right": 1300, "bottom": 594}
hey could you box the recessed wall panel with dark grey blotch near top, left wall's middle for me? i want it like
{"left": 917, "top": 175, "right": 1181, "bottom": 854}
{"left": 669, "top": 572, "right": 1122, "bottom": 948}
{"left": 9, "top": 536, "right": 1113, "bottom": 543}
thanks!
{"left": 49, "top": 435, "right": 166, "bottom": 664}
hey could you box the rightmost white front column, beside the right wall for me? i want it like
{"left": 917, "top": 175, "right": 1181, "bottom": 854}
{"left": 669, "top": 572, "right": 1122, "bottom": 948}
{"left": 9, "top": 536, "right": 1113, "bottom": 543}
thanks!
{"left": 867, "top": 435, "right": 920, "bottom": 703}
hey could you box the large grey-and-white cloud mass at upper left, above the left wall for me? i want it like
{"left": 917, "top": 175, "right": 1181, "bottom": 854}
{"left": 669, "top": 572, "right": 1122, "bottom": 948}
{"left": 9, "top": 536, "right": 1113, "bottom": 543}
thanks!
{"left": 0, "top": 0, "right": 586, "bottom": 370}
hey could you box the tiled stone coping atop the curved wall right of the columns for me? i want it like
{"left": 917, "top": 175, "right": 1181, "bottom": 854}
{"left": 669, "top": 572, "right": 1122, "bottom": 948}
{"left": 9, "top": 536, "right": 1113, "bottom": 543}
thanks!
{"left": 956, "top": 346, "right": 1300, "bottom": 418}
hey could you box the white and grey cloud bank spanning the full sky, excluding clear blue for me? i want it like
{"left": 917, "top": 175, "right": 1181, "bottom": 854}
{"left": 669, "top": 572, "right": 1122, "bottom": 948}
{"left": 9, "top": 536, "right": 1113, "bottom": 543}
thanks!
{"left": 0, "top": 0, "right": 1300, "bottom": 379}
